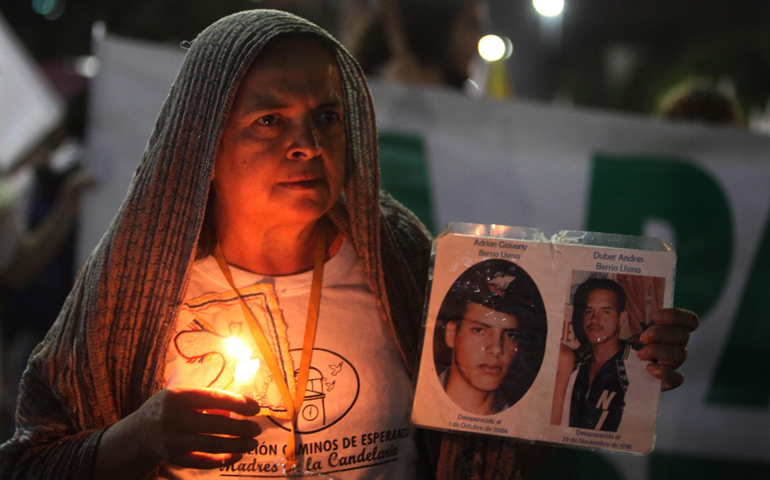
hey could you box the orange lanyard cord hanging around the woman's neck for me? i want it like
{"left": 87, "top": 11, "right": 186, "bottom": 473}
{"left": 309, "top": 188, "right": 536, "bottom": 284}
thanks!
{"left": 214, "top": 226, "right": 326, "bottom": 470}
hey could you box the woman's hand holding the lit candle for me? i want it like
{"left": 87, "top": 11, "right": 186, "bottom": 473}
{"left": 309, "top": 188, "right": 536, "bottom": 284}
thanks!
{"left": 93, "top": 386, "right": 261, "bottom": 479}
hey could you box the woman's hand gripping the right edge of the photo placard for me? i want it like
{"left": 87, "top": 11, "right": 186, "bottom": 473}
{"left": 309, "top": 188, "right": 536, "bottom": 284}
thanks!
{"left": 639, "top": 308, "right": 700, "bottom": 391}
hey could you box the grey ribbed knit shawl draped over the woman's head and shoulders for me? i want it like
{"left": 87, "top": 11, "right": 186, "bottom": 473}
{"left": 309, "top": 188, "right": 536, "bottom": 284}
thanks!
{"left": 0, "top": 10, "right": 513, "bottom": 479}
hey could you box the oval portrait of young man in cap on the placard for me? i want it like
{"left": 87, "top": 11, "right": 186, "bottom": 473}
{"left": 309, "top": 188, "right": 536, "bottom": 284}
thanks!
{"left": 436, "top": 260, "right": 546, "bottom": 415}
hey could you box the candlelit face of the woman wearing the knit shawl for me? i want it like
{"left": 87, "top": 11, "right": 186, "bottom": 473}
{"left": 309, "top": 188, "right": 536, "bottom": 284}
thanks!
{"left": 214, "top": 37, "right": 346, "bottom": 229}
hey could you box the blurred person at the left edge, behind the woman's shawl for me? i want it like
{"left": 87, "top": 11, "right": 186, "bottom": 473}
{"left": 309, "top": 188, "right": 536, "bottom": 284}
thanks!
{"left": 0, "top": 116, "right": 91, "bottom": 438}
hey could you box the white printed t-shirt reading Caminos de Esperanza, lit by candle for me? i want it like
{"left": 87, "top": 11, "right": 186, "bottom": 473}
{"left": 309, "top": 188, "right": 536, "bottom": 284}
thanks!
{"left": 160, "top": 242, "right": 417, "bottom": 480}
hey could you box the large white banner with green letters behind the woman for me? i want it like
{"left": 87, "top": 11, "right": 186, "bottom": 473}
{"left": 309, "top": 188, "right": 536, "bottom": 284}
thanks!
{"left": 81, "top": 32, "right": 770, "bottom": 480}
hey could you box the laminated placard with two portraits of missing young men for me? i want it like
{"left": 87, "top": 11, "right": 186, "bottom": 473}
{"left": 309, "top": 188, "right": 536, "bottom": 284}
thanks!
{"left": 411, "top": 223, "right": 676, "bottom": 454}
